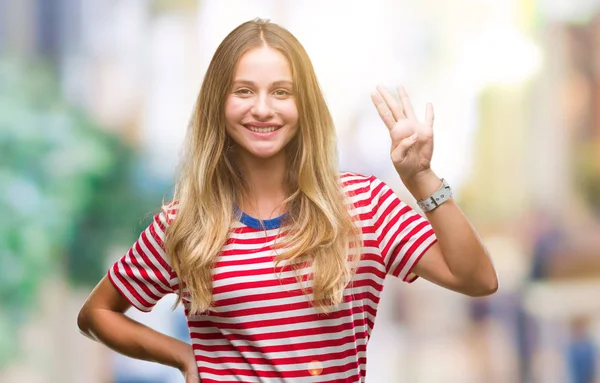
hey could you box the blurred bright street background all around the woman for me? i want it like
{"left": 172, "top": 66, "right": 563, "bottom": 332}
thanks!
{"left": 0, "top": 0, "right": 600, "bottom": 383}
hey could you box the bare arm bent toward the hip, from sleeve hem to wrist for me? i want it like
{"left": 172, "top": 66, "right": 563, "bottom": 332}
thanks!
{"left": 77, "top": 277, "right": 199, "bottom": 382}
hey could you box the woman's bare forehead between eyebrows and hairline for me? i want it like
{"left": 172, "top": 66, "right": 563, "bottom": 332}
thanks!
{"left": 234, "top": 46, "right": 292, "bottom": 81}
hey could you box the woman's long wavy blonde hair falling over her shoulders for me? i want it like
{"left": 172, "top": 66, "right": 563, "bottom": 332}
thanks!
{"left": 165, "top": 19, "right": 362, "bottom": 313}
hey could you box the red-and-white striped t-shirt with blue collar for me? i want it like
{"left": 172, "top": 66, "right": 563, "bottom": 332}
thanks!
{"left": 109, "top": 173, "right": 436, "bottom": 383}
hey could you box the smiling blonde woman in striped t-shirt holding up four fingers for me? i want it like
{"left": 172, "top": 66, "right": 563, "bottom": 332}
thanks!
{"left": 78, "top": 19, "right": 497, "bottom": 383}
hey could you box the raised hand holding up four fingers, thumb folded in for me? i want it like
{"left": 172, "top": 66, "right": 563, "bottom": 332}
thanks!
{"left": 371, "top": 86, "right": 433, "bottom": 182}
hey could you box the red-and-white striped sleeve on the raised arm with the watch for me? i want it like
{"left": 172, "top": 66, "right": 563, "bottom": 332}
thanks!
{"left": 371, "top": 177, "right": 437, "bottom": 283}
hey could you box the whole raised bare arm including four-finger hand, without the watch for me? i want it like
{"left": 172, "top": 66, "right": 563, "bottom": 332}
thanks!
{"left": 371, "top": 87, "right": 498, "bottom": 296}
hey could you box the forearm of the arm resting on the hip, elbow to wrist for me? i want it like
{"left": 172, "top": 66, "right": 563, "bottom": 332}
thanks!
{"left": 79, "top": 309, "right": 195, "bottom": 371}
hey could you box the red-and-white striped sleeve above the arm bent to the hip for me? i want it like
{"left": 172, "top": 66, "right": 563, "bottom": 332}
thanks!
{"left": 108, "top": 209, "right": 178, "bottom": 312}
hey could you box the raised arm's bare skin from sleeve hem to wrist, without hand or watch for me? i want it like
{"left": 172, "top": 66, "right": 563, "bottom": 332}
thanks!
{"left": 404, "top": 170, "right": 498, "bottom": 296}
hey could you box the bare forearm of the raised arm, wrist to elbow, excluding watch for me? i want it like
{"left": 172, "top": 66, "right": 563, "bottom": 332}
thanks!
{"left": 403, "top": 171, "right": 497, "bottom": 286}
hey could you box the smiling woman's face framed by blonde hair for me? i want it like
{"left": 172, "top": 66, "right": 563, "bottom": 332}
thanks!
{"left": 225, "top": 46, "right": 298, "bottom": 164}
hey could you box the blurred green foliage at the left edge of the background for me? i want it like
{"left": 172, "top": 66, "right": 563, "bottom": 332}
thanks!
{"left": 0, "top": 61, "right": 160, "bottom": 368}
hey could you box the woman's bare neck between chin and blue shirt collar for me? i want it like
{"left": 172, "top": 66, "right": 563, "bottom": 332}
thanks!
{"left": 234, "top": 153, "right": 287, "bottom": 219}
